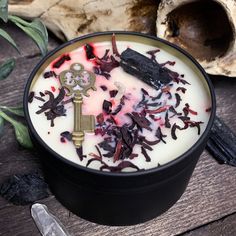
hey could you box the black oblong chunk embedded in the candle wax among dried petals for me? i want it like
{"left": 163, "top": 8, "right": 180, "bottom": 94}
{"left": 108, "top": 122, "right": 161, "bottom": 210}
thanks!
{"left": 120, "top": 48, "right": 171, "bottom": 89}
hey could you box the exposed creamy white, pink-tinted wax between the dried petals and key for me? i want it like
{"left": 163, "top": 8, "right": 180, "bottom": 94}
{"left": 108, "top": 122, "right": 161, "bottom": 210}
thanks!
{"left": 29, "top": 38, "right": 211, "bottom": 171}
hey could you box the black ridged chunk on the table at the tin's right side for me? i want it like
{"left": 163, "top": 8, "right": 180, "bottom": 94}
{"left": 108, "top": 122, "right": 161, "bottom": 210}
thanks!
{"left": 206, "top": 117, "right": 236, "bottom": 166}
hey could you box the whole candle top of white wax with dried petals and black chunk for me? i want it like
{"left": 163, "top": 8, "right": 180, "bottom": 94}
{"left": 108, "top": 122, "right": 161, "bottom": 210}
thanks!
{"left": 28, "top": 36, "right": 211, "bottom": 172}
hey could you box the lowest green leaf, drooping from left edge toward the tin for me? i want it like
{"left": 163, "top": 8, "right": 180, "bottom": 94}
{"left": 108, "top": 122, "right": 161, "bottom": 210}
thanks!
{"left": 0, "top": 110, "right": 33, "bottom": 149}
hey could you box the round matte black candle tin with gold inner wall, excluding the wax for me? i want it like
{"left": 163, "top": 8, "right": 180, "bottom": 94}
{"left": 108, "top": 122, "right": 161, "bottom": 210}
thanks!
{"left": 24, "top": 32, "right": 216, "bottom": 225}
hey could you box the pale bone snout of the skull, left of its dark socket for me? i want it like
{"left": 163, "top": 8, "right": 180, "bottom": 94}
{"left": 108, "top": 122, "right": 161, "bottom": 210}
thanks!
{"left": 9, "top": 0, "right": 157, "bottom": 40}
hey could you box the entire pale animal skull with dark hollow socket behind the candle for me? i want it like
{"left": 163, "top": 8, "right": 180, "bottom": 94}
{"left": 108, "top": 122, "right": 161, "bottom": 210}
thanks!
{"left": 9, "top": 0, "right": 236, "bottom": 76}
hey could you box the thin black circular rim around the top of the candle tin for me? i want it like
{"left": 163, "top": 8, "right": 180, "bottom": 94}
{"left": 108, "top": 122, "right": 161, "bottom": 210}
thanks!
{"left": 23, "top": 31, "right": 216, "bottom": 177}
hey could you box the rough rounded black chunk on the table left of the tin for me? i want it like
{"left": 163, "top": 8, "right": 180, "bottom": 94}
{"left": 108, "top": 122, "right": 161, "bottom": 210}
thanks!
{"left": 0, "top": 172, "right": 49, "bottom": 205}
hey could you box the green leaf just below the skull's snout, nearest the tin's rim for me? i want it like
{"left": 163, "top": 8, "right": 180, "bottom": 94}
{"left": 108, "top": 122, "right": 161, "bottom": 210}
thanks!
{"left": 8, "top": 16, "right": 48, "bottom": 55}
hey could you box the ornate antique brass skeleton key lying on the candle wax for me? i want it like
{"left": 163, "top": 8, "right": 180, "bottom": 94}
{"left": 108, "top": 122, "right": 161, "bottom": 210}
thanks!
{"left": 59, "top": 63, "right": 96, "bottom": 148}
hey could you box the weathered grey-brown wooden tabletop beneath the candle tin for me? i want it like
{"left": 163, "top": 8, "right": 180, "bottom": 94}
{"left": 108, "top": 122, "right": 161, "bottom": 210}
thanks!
{"left": 0, "top": 26, "right": 236, "bottom": 236}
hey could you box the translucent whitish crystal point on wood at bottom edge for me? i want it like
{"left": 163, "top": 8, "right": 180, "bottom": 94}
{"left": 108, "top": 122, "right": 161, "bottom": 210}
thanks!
{"left": 31, "top": 203, "right": 70, "bottom": 236}
